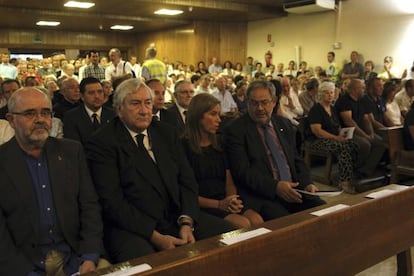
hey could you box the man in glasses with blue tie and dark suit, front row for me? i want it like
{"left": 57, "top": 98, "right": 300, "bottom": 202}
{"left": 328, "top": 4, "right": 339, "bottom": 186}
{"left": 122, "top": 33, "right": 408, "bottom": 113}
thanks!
{"left": 224, "top": 80, "right": 324, "bottom": 220}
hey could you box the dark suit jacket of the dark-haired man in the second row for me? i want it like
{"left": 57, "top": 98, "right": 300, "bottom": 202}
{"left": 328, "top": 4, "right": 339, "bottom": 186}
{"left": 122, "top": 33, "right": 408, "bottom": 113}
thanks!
{"left": 63, "top": 104, "right": 115, "bottom": 145}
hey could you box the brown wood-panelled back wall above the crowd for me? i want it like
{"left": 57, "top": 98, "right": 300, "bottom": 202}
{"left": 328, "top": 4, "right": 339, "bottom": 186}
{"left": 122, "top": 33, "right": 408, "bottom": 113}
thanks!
{"left": 0, "top": 21, "right": 247, "bottom": 65}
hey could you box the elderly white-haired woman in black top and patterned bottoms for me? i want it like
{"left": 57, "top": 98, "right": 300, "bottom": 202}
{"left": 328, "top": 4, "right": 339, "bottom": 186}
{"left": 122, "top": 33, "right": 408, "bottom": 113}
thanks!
{"left": 307, "top": 82, "right": 358, "bottom": 194}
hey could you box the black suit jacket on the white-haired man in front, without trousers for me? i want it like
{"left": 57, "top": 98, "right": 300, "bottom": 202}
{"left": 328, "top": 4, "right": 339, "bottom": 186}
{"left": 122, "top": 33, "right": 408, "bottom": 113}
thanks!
{"left": 86, "top": 117, "right": 199, "bottom": 239}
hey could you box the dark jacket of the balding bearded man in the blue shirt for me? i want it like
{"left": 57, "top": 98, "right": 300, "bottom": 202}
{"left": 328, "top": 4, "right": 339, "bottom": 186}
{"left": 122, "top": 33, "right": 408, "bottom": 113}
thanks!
{"left": 0, "top": 137, "right": 103, "bottom": 275}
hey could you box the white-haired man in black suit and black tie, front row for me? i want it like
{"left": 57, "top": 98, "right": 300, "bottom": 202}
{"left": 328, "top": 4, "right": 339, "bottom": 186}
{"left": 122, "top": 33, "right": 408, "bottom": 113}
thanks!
{"left": 86, "top": 79, "right": 233, "bottom": 262}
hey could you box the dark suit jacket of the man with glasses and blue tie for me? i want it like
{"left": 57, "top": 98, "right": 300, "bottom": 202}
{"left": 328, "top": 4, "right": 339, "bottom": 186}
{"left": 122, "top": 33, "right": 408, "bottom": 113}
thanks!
{"left": 224, "top": 114, "right": 312, "bottom": 199}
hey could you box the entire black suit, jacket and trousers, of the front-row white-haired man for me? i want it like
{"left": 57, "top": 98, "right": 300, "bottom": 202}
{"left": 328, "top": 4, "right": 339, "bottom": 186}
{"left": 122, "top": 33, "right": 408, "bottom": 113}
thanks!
{"left": 86, "top": 118, "right": 231, "bottom": 262}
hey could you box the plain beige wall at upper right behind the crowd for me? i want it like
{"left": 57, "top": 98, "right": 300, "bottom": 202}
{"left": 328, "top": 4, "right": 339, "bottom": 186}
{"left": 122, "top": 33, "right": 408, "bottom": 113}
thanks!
{"left": 247, "top": 0, "right": 414, "bottom": 74}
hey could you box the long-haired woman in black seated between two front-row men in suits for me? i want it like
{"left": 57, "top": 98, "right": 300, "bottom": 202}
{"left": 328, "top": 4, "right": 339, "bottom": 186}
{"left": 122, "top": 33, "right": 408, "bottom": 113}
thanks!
{"left": 183, "top": 93, "right": 263, "bottom": 227}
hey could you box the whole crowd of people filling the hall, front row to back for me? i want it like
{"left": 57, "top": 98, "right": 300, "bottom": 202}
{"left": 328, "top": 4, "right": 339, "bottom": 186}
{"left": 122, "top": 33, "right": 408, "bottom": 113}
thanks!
{"left": 0, "top": 47, "right": 414, "bottom": 275}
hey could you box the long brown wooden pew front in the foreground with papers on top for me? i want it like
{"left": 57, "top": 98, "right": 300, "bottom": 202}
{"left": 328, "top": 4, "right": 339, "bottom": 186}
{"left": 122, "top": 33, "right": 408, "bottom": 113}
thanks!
{"left": 89, "top": 185, "right": 414, "bottom": 276}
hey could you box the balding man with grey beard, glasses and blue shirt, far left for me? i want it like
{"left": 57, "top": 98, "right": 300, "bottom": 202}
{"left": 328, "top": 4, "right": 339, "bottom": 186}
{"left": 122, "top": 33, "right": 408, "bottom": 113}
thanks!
{"left": 0, "top": 87, "right": 103, "bottom": 275}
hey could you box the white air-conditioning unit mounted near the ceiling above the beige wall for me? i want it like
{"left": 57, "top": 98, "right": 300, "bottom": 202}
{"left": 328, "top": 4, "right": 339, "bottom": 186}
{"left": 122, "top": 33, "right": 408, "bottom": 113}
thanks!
{"left": 283, "top": 0, "right": 335, "bottom": 14}
